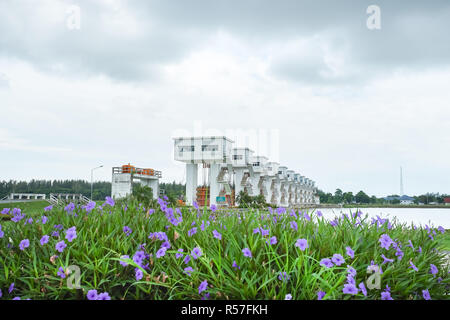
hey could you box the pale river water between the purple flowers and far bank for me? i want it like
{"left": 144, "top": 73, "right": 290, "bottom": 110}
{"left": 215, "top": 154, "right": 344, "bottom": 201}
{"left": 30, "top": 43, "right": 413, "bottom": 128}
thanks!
{"left": 317, "top": 208, "right": 450, "bottom": 229}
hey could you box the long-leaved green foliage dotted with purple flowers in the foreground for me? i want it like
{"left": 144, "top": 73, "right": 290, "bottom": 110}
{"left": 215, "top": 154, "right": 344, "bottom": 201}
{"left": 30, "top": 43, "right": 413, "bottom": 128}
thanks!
{"left": 0, "top": 202, "right": 449, "bottom": 300}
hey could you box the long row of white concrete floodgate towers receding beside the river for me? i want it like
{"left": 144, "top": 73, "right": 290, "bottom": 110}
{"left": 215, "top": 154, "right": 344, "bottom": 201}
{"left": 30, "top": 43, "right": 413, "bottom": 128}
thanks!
{"left": 174, "top": 136, "right": 319, "bottom": 207}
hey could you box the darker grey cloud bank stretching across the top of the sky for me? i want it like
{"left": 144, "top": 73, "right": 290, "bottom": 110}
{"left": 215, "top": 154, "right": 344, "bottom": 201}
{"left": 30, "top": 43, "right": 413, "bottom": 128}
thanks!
{"left": 0, "top": 0, "right": 450, "bottom": 85}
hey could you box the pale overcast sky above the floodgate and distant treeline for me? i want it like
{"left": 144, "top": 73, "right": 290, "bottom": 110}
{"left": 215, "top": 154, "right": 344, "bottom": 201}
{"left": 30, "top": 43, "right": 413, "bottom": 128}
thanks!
{"left": 0, "top": 0, "right": 450, "bottom": 196}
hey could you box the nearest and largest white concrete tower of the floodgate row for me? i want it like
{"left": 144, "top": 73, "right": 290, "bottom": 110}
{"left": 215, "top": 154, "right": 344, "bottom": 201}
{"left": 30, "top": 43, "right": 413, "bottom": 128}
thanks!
{"left": 174, "top": 136, "right": 233, "bottom": 205}
